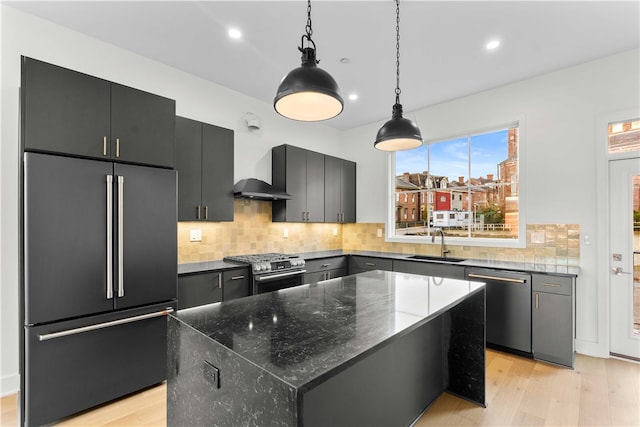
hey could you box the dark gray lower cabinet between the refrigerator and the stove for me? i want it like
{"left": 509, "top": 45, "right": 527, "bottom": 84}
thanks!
{"left": 178, "top": 268, "right": 250, "bottom": 309}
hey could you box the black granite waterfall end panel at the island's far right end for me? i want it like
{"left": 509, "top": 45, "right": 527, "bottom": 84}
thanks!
{"left": 443, "top": 288, "right": 486, "bottom": 407}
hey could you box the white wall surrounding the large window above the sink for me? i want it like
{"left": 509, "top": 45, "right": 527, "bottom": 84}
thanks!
{"left": 344, "top": 50, "right": 640, "bottom": 356}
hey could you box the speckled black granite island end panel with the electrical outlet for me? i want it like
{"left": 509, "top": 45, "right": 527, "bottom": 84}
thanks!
{"left": 167, "top": 316, "right": 297, "bottom": 427}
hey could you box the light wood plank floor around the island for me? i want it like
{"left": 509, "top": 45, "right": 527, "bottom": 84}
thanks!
{"left": 1, "top": 350, "right": 640, "bottom": 427}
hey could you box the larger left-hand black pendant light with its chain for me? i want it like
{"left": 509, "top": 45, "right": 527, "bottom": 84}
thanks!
{"left": 273, "top": 0, "right": 344, "bottom": 122}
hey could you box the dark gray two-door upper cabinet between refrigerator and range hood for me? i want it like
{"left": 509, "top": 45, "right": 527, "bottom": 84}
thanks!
{"left": 176, "top": 117, "right": 234, "bottom": 221}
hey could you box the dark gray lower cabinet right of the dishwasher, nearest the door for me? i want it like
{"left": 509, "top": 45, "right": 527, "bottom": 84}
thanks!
{"left": 531, "top": 274, "right": 575, "bottom": 367}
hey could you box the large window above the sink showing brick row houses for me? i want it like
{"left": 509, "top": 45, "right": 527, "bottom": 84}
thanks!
{"left": 389, "top": 124, "right": 520, "bottom": 244}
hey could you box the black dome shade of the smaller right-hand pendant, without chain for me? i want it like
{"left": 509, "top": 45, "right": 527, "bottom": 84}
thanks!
{"left": 373, "top": 104, "right": 422, "bottom": 151}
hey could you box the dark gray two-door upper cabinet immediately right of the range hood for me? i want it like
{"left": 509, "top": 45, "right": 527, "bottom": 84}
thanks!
{"left": 271, "top": 145, "right": 325, "bottom": 222}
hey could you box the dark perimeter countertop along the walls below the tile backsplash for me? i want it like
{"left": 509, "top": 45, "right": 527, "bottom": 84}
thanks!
{"left": 178, "top": 249, "right": 580, "bottom": 277}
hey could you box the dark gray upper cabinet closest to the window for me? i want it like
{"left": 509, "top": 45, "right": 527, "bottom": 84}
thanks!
{"left": 324, "top": 156, "right": 356, "bottom": 222}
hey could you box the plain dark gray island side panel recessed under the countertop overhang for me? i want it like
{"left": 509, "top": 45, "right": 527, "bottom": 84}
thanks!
{"left": 299, "top": 316, "right": 445, "bottom": 427}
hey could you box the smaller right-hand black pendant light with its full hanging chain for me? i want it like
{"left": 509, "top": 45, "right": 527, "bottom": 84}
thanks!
{"left": 373, "top": 0, "right": 422, "bottom": 151}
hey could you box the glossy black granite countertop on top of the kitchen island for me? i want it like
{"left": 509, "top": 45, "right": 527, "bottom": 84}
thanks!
{"left": 172, "top": 270, "right": 484, "bottom": 388}
